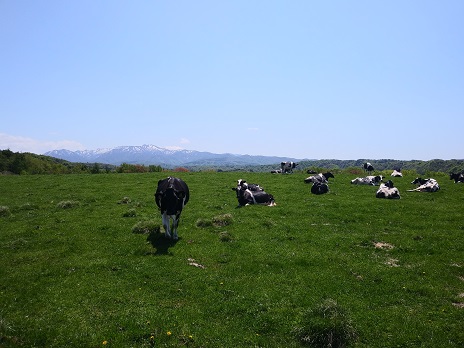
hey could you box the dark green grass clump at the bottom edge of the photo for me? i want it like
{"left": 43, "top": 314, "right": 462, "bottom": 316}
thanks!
{"left": 295, "top": 299, "right": 357, "bottom": 348}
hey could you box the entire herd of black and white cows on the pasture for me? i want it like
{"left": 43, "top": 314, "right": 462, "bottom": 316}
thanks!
{"left": 155, "top": 162, "right": 464, "bottom": 240}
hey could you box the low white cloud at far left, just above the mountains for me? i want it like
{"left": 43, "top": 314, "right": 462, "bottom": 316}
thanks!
{"left": 0, "top": 133, "right": 85, "bottom": 154}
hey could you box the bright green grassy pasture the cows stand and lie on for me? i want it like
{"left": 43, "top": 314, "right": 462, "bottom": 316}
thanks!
{"left": 0, "top": 172, "right": 464, "bottom": 347}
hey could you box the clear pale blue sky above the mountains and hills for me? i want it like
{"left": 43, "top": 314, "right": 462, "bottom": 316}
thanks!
{"left": 0, "top": 0, "right": 464, "bottom": 160}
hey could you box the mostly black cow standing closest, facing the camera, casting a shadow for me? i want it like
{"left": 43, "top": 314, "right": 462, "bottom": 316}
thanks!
{"left": 155, "top": 176, "right": 190, "bottom": 240}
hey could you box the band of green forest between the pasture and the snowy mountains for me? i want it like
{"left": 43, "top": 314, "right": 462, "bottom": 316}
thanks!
{"left": 0, "top": 150, "right": 464, "bottom": 175}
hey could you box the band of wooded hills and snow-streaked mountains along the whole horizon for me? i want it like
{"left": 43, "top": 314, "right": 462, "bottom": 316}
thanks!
{"left": 0, "top": 146, "right": 464, "bottom": 175}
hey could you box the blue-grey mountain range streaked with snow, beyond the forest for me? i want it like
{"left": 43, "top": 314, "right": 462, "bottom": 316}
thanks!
{"left": 44, "top": 145, "right": 300, "bottom": 168}
